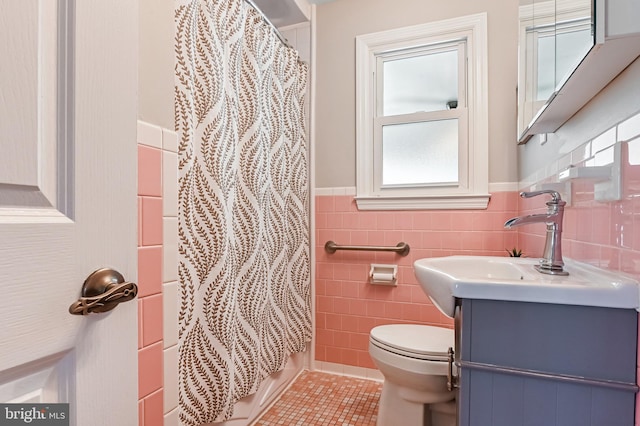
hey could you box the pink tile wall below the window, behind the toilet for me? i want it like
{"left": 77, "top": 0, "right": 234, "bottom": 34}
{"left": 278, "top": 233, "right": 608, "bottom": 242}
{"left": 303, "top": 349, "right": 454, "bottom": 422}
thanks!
{"left": 315, "top": 192, "right": 518, "bottom": 368}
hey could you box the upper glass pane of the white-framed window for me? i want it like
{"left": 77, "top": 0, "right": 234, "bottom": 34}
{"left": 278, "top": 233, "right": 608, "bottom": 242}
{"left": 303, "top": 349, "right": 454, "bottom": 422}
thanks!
{"left": 382, "top": 49, "right": 458, "bottom": 116}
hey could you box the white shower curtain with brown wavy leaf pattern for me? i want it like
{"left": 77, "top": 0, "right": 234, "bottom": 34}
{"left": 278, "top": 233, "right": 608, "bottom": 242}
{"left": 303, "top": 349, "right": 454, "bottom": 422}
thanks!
{"left": 175, "top": 0, "right": 311, "bottom": 426}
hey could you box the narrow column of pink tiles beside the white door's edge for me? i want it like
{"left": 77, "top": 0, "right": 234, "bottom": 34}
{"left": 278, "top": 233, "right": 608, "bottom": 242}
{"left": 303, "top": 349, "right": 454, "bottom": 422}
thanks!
{"left": 138, "top": 145, "right": 163, "bottom": 426}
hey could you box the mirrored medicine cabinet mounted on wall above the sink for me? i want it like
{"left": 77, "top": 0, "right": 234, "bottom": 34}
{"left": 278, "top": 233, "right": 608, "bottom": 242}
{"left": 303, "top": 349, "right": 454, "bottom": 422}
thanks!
{"left": 518, "top": 0, "right": 640, "bottom": 143}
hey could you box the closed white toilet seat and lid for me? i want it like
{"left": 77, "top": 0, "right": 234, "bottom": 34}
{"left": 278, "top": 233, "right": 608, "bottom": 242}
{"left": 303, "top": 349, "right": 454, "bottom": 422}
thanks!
{"left": 369, "top": 324, "right": 454, "bottom": 362}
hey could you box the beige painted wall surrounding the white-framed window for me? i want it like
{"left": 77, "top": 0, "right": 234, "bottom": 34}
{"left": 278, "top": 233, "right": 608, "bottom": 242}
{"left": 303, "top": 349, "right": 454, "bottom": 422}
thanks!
{"left": 315, "top": 0, "right": 518, "bottom": 188}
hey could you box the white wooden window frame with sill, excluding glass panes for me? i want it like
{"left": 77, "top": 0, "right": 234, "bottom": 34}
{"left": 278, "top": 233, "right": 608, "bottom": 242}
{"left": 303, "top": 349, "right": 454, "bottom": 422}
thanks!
{"left": 355, "top": 13, "right": 490, "bottom": 210}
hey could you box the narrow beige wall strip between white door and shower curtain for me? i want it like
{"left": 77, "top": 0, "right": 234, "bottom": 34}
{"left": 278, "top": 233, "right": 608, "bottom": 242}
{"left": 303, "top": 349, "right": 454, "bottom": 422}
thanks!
{"left": 138, "top": 0, "right": 174, "bottom": 129}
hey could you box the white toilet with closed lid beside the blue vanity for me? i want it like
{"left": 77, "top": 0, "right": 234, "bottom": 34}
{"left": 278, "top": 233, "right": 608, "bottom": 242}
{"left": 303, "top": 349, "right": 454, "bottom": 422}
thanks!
{"left": 369, "top": 324, "right": 456, "bottom": 426}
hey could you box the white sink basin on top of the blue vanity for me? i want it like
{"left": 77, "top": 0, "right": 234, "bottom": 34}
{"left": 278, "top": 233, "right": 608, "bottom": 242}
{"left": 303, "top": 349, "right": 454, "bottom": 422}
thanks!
{"left": 413, "top": 256, "right": 640, "bottom": 317}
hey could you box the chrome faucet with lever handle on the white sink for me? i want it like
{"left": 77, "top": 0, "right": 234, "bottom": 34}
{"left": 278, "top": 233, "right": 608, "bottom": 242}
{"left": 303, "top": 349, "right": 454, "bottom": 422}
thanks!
{"left": 504, "top": 190, "right": 569, "bottom": 275}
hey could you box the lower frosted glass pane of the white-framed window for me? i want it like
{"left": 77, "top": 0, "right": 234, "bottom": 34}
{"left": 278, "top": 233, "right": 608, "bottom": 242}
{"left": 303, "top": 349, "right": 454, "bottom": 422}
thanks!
{"left": 382, "top": 119, "right": 458, "bottom": 186}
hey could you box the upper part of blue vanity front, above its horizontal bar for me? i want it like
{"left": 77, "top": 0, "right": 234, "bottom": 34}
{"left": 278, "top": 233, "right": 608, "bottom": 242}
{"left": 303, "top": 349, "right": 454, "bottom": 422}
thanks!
{"left": 461, "top": 300, "right": 638, "bottom": 383}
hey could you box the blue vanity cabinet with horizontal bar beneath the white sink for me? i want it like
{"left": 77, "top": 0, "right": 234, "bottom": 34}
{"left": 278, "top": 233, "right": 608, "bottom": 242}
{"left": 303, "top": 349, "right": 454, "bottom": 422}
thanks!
{"left": 456, "top": 299, "right": 638, "bottom": 426}
